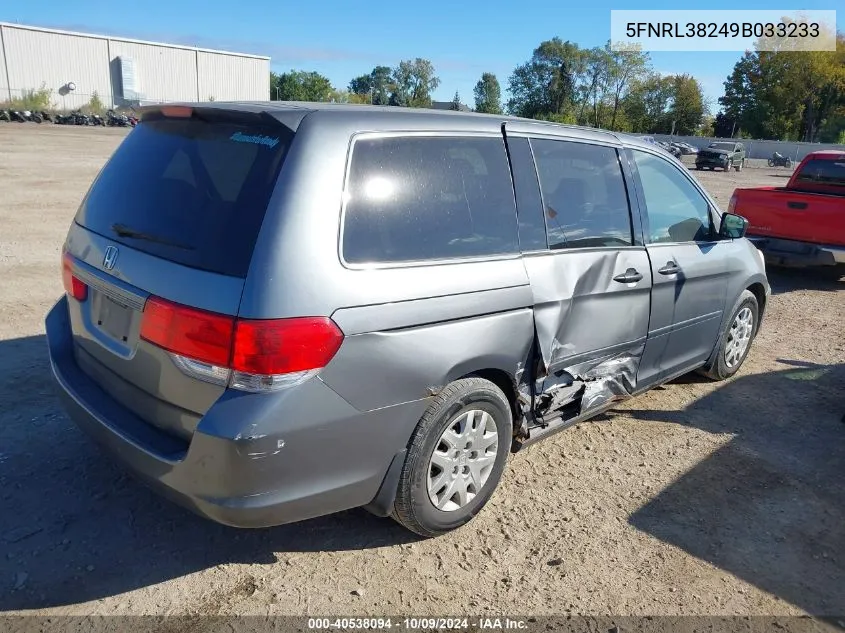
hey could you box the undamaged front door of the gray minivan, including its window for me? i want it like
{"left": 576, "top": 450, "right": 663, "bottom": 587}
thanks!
{"left": 629, "top": 150, "right": 730, "bottom": 386}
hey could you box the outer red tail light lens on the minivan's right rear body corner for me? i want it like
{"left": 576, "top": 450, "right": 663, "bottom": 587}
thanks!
{"left": 232, "top": 317, "right": 343, "bottom": 375}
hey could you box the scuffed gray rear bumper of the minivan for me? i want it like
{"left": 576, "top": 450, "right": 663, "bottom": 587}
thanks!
{"left": 46, "top": 298, "right": 428, "bottom": 528}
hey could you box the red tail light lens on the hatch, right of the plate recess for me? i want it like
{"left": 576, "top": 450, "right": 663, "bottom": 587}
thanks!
{"left": 141, "top": 297, "right": 235, "bottom": 367}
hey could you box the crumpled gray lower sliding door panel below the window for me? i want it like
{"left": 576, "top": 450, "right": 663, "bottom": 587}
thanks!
{"left": 525, "top": 247, "right": 651, "bottom": 417}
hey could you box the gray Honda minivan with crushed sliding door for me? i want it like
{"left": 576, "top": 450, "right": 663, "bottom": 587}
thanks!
{"left": 46, "top": 102, "right": 770, "bottom": 536}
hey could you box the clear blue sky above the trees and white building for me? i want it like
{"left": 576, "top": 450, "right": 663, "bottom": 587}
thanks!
{"left": 0, "top": 0, "right": 845, "bottom": 113}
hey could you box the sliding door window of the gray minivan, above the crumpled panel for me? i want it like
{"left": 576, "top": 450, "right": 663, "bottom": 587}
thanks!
{"left": 531, "top": 139, "right": 632, "bottom": 249}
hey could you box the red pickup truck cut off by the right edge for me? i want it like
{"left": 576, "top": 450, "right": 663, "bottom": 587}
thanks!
{"left": 728, "top": 150, "right": 845, "bottom": 274}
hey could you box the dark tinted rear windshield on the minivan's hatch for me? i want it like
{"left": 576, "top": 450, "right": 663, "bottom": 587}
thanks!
{"left": 76, "top": 115, "right": 292, "bottom": 277}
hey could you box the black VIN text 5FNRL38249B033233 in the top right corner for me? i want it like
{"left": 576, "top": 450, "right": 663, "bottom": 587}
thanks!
{"left": 625, "top": 22, "right": 822, "bottom": 39}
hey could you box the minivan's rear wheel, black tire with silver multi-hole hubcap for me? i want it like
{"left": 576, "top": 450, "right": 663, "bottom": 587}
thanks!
{"left": 393, "top": 378, "right": 513, "bottom": 537}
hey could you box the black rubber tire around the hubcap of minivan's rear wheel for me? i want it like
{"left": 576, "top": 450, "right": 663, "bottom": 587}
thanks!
{"left": 393, "top": 377, "right": 513, "bottom": 537}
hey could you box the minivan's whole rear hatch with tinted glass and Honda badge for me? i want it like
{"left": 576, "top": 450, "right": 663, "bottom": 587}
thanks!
{"left": 64, "top": 106, "right": 293, "bottom": 439}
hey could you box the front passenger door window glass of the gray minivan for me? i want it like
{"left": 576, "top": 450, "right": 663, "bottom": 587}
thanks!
{"left": 632, "top": 150, "right": 712, "bottom": 244}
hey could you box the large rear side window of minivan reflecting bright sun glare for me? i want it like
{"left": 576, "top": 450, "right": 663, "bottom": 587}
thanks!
{"left": 342, "top": 137, "right": 518, "bottom": 264}
